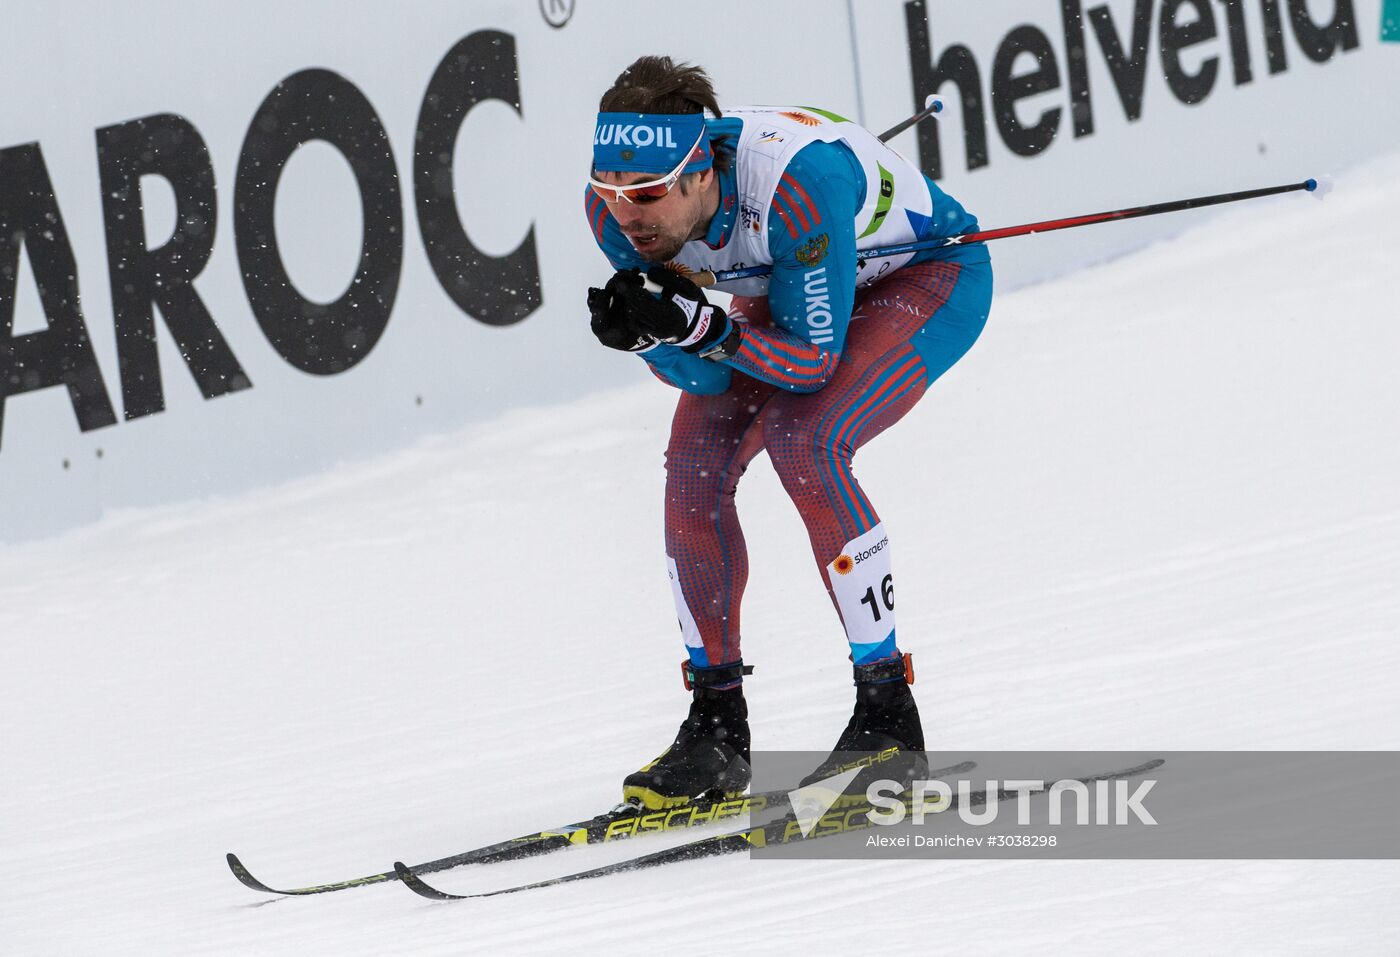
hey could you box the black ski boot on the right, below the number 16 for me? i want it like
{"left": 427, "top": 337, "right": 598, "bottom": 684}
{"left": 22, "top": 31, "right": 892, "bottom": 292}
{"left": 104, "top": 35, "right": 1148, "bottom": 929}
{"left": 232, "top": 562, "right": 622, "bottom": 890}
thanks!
{"left": 802, "top": 655, "right": 928, "bottom": 796}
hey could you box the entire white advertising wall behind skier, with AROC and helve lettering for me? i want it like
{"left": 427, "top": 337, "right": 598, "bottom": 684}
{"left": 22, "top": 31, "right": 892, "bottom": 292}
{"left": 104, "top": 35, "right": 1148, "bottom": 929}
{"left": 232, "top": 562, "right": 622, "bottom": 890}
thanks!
{"left": 0, "top": 0, "right": 1400, "bottom": 541}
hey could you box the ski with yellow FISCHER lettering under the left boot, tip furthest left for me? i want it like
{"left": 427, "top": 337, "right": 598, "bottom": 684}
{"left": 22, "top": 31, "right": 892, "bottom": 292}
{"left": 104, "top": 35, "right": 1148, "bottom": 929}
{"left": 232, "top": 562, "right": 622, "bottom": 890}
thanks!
{"left": 227, "top": 761, "right": 976, "bottom": 897}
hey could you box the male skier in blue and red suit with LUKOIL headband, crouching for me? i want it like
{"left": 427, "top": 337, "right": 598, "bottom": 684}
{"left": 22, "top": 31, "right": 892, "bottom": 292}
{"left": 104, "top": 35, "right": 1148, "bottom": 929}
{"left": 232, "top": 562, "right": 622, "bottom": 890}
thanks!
{"left": 585, "top": 56, "right": 991, "bottom": 809}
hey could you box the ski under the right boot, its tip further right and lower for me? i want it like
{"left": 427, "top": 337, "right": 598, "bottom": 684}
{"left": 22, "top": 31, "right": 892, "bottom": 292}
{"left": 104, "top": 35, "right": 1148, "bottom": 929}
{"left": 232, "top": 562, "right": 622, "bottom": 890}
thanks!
{"left": 393, "top": 758, "right": 1166, "bottom": 901}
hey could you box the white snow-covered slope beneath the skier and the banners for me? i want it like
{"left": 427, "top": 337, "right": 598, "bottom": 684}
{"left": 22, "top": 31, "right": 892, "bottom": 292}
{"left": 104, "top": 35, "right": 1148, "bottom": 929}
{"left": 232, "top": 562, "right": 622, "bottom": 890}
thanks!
{"left": 0, "top": 155, "right": 1400, "bottom": 956}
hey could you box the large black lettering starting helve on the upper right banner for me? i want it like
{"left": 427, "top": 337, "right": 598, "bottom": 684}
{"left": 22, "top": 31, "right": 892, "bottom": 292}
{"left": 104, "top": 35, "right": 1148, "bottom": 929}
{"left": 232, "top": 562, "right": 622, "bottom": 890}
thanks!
{"left": 904, "top": 0, "right": 1361, "bottom": 179}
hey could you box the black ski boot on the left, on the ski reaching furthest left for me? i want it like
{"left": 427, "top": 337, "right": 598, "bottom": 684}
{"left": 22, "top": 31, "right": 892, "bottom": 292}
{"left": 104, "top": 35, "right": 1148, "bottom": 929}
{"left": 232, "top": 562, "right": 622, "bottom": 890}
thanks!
{"left": 622, "top": 662, "right": 753, "bottom": 810}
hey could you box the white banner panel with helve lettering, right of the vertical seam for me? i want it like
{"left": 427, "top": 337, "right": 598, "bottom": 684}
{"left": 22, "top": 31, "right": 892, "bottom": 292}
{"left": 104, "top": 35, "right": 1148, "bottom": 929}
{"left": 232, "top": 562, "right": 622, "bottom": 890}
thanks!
{"left": 855, "top": 0, "right": 1400, "bottom": 284}
